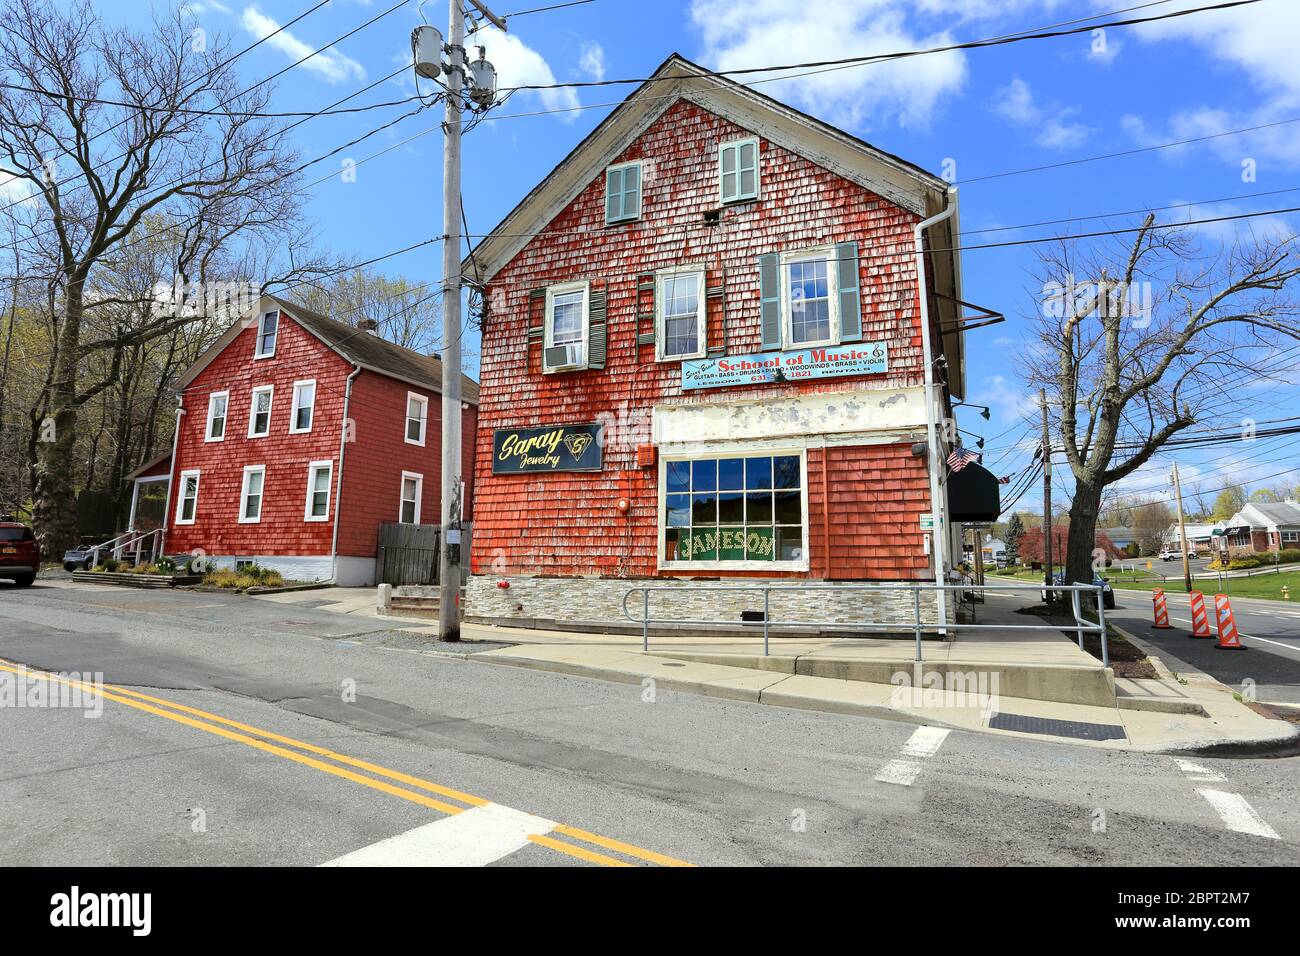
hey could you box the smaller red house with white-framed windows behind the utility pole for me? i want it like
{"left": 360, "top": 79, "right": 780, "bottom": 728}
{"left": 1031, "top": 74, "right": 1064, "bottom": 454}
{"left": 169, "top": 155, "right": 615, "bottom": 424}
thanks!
{"left": 165, "top": 295, "right": 478, "bottom": 585}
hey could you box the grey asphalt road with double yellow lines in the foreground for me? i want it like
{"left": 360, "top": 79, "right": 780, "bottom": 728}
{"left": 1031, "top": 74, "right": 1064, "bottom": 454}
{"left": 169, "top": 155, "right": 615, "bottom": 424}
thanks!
{"left": 0, "top": 574, "right": 1300, "bottom": 866}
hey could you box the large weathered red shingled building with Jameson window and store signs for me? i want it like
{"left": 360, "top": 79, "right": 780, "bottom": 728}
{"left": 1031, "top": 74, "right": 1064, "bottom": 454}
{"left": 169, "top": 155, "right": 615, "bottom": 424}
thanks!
{"left": 465, "top": 56, "right": 997, "bottom": 624}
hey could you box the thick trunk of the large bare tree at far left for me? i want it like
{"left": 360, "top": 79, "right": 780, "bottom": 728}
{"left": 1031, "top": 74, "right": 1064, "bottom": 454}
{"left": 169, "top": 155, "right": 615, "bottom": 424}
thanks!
{"left": 33, "top": 276, "right": 85, "bottom": 561}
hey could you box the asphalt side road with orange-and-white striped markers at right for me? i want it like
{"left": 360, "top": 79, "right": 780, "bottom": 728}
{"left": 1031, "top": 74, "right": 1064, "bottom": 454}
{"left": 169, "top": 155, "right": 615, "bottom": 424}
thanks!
{"left": 1108, "top": 588, "right": 1300, "bottom": 706}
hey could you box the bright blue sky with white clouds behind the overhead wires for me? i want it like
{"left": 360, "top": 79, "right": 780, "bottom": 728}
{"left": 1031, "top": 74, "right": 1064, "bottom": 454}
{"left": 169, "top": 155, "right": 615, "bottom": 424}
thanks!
{"left": 109, "top": 0, "right": 1300, "bottom": 510}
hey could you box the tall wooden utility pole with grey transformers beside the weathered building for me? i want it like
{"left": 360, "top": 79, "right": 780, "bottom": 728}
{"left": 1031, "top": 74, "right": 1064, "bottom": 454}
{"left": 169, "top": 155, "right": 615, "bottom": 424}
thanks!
{"left": 412, "top": 0, "right": 506, "bottom": 641}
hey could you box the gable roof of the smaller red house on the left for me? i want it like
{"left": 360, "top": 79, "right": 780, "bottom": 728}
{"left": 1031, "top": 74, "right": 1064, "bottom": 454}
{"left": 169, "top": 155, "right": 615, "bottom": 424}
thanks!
{"left": 176, "top": 295, "right": 478, "bottom": 405}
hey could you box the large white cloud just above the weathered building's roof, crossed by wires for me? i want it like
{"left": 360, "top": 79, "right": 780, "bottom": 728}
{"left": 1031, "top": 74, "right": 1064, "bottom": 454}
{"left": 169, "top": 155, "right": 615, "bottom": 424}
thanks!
{"left": 690, "top": 0, "right": 966, "bottom": 127}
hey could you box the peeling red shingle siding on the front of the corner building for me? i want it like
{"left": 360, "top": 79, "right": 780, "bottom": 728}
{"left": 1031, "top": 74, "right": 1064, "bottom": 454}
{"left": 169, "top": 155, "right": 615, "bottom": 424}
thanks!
{"left": 473, "top": 101, "right": 930, "bottom": 579}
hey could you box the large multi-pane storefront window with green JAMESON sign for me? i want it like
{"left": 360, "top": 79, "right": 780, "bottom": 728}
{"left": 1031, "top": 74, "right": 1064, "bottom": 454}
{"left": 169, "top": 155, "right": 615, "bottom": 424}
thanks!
{"left": 662, "top": 455, "right": 803, "bottom": 563}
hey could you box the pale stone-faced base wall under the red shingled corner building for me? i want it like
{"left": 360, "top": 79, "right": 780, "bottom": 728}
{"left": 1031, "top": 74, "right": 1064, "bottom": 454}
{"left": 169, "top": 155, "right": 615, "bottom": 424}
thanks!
{"left": 464, "top": 575, "right": 954, "bottom": 633}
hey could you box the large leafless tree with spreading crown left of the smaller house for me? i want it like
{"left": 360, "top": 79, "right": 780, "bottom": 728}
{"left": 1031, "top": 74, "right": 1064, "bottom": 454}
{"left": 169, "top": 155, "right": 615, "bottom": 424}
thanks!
{"left": 0, "top": 0, "right": 312, "bottom": 554}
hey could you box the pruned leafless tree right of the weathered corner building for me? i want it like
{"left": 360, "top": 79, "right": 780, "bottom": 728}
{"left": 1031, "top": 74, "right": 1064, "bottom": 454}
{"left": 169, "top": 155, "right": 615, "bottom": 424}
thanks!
{"left": 1026, "top": 216, "right": 1300, "bottom": 590}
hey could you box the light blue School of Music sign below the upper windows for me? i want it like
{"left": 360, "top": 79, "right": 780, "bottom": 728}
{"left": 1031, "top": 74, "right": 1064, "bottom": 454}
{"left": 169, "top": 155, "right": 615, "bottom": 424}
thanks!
{"left": 681, "top": 342, "right": 889, "bottom": 389}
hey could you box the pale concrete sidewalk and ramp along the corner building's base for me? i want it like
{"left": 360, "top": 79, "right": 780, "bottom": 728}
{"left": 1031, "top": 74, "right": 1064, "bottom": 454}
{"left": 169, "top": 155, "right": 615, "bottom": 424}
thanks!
{"left": 248, "top": 588, "right": 1296, "bottom": 752}
